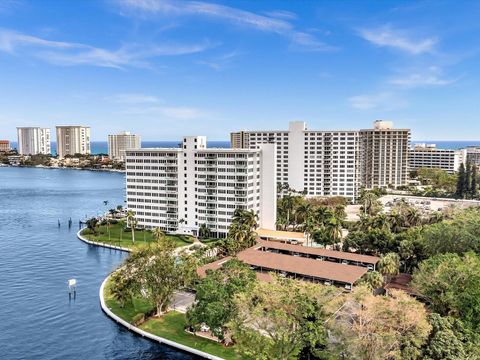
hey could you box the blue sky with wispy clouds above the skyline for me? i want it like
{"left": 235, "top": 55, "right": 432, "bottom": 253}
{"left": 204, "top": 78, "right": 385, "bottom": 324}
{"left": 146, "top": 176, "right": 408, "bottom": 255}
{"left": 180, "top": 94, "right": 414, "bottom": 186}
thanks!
{"left": 0, "top": 0, "right": 480, "bottom": 140}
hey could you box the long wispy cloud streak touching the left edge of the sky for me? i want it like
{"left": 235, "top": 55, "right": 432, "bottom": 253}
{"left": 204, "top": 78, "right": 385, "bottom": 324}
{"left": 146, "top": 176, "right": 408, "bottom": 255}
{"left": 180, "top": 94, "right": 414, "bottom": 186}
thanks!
{"left": 0, "top": 29, "right": 212, "bottom": 69}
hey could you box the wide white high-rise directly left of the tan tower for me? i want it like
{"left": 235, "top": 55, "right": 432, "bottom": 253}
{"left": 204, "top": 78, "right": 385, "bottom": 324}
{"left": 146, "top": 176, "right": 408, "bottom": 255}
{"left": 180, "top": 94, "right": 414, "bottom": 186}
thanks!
{"left": 231, "top": 121, "right": 358, "bottom": 198}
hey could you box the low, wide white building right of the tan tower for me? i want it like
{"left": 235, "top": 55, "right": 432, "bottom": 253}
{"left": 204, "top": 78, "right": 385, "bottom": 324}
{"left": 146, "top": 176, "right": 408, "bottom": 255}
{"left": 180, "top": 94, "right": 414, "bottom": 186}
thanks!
{"left": 408, "top": 144, "right": 467, "bottom": 174}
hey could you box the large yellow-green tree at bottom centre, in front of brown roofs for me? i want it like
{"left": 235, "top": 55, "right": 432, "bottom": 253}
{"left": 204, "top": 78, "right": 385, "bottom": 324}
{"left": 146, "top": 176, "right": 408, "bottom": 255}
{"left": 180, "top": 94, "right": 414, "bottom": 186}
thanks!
{"left": 232, "top": 278, "right": 326, "bottom": 360}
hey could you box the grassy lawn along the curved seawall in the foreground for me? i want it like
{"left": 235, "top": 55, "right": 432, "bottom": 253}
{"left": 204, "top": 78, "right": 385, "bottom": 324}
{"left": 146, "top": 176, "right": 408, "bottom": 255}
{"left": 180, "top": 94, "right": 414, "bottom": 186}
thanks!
{"left": 104, "top": 283, "right": 240, "bottom": 359}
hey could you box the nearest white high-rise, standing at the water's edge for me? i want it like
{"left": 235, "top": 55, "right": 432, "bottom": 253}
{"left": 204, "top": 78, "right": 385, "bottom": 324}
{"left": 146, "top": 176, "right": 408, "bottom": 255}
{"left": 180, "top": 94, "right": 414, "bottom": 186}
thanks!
{"left": 126, "top": 136, "right": 277, "bottom": 237}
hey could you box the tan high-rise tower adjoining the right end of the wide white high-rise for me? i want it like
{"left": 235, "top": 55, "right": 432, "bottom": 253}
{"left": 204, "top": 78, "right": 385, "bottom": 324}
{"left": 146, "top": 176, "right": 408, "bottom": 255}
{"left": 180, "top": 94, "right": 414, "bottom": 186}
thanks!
{"left": 359, "top": 120, "right": 410, "bottom": 189}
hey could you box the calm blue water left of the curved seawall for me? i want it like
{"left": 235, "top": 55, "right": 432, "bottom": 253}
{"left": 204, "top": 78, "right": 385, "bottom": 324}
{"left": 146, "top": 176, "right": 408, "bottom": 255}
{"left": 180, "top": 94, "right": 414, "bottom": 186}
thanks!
{"left": 0, "top": 167, "right": 195, "bottom": 360}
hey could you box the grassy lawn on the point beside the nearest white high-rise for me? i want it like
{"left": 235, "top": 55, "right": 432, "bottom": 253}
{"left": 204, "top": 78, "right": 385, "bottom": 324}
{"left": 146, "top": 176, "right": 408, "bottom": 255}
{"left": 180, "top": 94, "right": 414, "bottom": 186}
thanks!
{"left": 82, "top": 222, "right": 193, "bottom": 249}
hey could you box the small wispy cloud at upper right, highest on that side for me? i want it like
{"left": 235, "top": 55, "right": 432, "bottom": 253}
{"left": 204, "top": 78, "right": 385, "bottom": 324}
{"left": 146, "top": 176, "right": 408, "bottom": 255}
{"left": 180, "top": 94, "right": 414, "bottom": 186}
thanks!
{"left": 359, "top": 26, "right": 438, "bottom": 55}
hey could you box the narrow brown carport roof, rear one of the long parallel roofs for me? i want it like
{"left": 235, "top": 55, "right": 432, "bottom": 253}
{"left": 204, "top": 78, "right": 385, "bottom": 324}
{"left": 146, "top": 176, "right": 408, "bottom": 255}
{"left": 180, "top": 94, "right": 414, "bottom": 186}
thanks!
{"left": 257, "top": 240, "right": 380, "bottom": 267}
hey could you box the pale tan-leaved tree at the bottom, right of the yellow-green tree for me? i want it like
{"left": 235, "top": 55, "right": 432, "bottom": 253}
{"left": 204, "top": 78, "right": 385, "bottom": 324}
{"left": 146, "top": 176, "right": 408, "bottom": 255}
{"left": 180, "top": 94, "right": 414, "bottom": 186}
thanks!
{"left": 328, "top": 287, "right": 431, "bottom": 360}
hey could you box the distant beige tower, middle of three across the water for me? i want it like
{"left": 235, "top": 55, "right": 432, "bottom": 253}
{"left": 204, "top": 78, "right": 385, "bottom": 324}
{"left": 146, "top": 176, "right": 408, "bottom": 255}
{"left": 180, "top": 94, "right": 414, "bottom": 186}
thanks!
{"left": 57, "top": 126, "right": 90, "bottom": 159}
